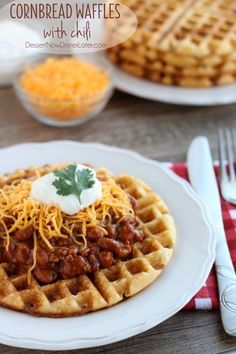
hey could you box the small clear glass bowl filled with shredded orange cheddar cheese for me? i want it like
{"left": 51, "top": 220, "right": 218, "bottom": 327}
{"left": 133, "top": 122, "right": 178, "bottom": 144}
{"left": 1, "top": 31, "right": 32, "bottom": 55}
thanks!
{"left": 14, "top": 57, "right": 113, "bottom": 127}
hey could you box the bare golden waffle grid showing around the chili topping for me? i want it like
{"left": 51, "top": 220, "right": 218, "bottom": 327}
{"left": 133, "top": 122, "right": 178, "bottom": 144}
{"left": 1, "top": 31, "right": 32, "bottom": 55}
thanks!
{"left": 0, "top": 170, "right": 176, "bottom": 317}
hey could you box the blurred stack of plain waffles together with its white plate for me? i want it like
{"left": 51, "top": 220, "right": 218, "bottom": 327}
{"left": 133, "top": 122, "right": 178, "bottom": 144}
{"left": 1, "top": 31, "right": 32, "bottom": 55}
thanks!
{"left": 104, "top": 0, "right": 236, "bottom": 105}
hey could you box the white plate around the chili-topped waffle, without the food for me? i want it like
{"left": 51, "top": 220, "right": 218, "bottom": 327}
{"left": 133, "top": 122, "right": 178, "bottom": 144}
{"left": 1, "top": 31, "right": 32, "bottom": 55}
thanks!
{"left": 0, "top": 141, "right": 215, "bottom": 350}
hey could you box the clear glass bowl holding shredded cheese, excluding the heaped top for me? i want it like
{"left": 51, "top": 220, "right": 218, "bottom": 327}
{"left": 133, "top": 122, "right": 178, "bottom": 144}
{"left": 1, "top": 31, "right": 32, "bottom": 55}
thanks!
{"left": 14, "top": 56, "right": 114, "bottom": 127}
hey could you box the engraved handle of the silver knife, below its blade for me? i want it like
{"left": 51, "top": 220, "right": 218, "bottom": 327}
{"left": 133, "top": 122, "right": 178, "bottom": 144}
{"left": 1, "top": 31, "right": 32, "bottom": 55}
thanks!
{"left": 215, "top": 229, "right": 236, "bottom": 336}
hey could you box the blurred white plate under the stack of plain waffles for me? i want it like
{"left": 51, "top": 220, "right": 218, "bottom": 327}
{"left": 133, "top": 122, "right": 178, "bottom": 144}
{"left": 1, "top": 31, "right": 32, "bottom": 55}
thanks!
{"left": 111, "top": 64, "right": 236, "bottom": 106}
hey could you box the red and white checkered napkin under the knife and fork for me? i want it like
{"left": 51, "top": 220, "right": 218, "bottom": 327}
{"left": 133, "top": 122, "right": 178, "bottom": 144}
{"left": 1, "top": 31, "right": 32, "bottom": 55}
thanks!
{"left": 170, "top": 163, "right": 236, "bottom": 310}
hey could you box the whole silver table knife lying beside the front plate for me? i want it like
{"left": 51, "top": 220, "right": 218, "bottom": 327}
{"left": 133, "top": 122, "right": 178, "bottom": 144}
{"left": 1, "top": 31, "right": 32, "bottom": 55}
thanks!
{"left": 187, "top": 136, "right": 236, "bottom": 336}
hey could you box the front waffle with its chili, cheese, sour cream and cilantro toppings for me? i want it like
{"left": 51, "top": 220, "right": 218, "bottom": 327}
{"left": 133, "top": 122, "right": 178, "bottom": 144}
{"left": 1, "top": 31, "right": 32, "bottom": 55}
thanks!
{"left": 0, "top": 164, "right": 176, "bottom": 317}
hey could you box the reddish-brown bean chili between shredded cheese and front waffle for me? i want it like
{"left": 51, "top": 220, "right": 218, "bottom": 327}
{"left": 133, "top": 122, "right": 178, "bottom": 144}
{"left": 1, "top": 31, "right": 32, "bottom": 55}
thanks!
{"left": 0, "top": 212, "right": 143, "bottom": 284}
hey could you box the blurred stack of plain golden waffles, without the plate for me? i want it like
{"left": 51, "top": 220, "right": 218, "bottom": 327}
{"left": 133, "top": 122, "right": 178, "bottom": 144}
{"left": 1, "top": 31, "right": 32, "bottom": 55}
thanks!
{"left": 108, "top": 0, "right": 236, "bottom": 87}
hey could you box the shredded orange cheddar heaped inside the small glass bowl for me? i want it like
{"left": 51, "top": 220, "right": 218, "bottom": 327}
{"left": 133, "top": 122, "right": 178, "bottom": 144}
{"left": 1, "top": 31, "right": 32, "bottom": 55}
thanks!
{"left": 20, "top": 57, "right": 109, "bottom": 120}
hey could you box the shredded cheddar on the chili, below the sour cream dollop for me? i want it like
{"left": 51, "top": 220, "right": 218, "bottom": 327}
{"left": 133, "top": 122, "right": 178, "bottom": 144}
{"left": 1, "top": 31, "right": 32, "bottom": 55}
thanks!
{"left": 0, "top": 168, "right": 134, "bottom": 248}
